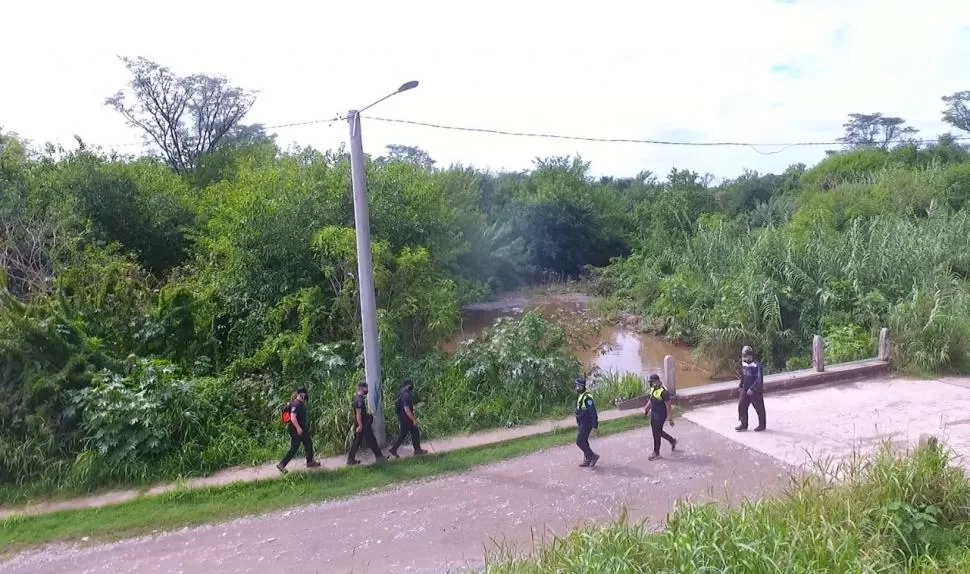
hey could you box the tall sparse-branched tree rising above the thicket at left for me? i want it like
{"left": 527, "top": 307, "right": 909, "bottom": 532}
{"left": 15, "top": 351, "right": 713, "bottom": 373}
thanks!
{"left": 105, "top": 57, "right": 261, "bottom": 175}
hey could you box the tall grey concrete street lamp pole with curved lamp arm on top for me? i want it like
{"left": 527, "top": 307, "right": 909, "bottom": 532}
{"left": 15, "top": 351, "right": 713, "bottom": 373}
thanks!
{"left": 347, "top": 81, "right": 418, "bottom": 447}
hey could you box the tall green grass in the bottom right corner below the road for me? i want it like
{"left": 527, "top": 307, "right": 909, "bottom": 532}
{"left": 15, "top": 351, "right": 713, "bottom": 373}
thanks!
{"left": 486, "top": 447, "right": 970, "bottom": 574}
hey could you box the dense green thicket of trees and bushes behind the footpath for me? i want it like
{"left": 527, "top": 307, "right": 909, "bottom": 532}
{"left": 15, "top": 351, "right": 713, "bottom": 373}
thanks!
{"left": 0, "top": 59, "right": 970, "bottom": 502}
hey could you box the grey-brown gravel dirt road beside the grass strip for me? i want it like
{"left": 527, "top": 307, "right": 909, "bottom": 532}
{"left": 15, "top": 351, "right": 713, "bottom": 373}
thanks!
{"left": 0, "top": 419, "right": 789, "bottom": 574}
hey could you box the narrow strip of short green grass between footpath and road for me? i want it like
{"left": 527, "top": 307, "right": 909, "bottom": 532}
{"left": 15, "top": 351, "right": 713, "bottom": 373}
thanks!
{"left": 0, "top": 416, "right": 646, "bottom": 552}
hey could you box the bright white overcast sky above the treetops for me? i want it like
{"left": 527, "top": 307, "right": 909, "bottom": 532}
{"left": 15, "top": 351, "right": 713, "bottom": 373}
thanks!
{"left": 0, "top": 0, "right": 970, "bottom": 177}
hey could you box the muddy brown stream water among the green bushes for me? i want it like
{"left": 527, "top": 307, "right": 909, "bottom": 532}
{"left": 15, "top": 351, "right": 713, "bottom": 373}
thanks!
{"left": 446, "top": 295, "right": 711, "bottom": 388}
